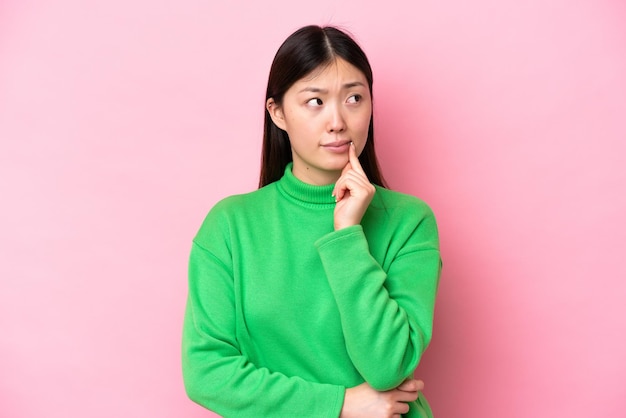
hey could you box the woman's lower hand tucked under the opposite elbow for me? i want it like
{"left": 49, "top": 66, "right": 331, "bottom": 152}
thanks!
{"left": 340, "top": 379, "right": 424, "bottom": 418}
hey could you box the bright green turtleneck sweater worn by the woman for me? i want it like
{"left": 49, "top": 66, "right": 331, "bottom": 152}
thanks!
{"left": 182, "top": 165, "right": 441, "bottom": 418}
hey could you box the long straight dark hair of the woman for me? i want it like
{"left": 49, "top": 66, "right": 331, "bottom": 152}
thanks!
{"left": 259, "top": 25, "right": 385, "bottom": 187}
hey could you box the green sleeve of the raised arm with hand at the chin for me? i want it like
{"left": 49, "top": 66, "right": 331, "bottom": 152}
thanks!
{"left": 316, "top": 205, "right": 441, "bottom": 390}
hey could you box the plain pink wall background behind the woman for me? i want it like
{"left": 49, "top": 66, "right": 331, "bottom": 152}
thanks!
{"left": 0, "top": 0, "right": 626, "bottom": 418}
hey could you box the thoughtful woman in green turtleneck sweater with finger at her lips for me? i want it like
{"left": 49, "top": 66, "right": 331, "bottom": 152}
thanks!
{"left": 183, "top": 26, "right": 441, "bottom": 418}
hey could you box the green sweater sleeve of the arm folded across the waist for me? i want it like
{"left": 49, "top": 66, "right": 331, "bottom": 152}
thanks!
{"left": 182, "top": 233, "right": 344, "bottom": 418}
